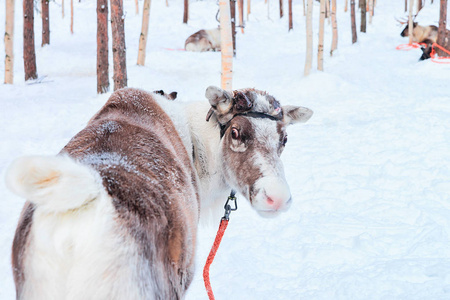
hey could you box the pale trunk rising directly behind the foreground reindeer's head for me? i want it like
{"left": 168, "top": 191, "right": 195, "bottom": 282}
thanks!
{"left": 219, "top": 0, "right": 233, "bottom": 91}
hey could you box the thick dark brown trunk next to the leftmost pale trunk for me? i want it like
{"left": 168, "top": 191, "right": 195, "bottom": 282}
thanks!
{"left": 23, "top": 0, "right": 37, "bottom": 80}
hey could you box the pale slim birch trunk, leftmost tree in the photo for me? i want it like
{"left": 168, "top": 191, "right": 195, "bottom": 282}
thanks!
{"left": 5, "top": 0, "right": 14, "bottom": 84}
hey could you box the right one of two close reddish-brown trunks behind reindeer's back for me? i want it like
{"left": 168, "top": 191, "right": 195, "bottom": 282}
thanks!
{"left": 111, "top": 0, "right": 127, "bottom": 91}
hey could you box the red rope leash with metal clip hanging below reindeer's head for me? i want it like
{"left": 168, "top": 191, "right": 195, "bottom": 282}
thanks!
{"left": 203, "top": 191, "right": 237, "bottom": 300}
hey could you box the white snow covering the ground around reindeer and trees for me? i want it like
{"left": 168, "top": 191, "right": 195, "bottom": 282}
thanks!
{"left": 0, "top": 0, "right": 450, "bottom": 300}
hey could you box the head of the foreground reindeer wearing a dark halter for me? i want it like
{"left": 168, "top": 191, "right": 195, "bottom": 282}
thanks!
{"left": 206, "top": 87, "right": 313, "bottom": 217}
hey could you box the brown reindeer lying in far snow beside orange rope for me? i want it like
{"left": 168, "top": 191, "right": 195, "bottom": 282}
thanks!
{"left": 399, "top": 21, "right": 438, "bottom": 60}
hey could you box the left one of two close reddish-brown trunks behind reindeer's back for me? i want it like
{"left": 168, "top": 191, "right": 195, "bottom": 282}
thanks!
{"left": 97, "top": 0, "right": 109, "bottom": 94}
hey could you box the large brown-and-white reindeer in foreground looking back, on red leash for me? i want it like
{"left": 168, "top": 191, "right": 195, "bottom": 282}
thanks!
{"left": 6, "top": 87, "right": 312, "bottom": 300}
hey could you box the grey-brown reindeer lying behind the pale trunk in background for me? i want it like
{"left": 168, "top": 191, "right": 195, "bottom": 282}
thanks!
{"left": 184, "top": 28, "right": 220, "bottom": 52}
